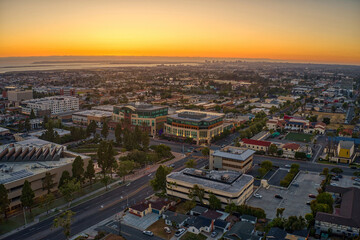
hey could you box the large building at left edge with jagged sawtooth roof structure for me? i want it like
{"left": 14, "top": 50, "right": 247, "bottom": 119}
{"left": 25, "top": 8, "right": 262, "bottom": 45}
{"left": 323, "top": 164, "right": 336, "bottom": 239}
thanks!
{"left": 0, "top": 138, "right": 90, "bottom": 210}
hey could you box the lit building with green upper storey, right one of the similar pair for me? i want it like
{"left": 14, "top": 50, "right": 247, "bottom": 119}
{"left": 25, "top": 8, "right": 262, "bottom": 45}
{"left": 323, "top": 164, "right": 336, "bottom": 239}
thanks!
{"left": 165, "top": 110, "right": 224, "bottom": 144}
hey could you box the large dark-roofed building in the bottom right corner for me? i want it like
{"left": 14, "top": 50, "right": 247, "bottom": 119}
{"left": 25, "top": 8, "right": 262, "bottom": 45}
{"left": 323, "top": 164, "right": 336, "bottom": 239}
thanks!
{"left": 315, "top": 186, "right": 360, "bottom": 237}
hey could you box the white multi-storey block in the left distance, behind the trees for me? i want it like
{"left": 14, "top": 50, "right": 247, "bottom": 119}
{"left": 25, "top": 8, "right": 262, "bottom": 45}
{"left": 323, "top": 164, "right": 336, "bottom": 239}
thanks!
{"left": 21, "top": 96, "right": 79, "bottom": 116}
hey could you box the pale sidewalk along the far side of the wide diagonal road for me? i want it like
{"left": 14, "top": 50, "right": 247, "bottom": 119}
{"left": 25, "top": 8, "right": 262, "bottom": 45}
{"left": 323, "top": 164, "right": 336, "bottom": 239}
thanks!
{"left": 0, "top": 152, "right": 185, "bottom": 239}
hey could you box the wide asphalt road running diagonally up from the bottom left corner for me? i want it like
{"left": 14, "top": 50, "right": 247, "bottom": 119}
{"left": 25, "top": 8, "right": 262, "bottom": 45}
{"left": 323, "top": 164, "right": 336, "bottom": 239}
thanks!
{"left": 3, "top": 153, "right": 207, "bottom": 240}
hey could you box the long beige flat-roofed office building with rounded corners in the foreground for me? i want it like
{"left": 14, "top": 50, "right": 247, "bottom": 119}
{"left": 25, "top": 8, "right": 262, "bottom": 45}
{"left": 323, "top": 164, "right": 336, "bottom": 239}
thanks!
{"left": 166, "top": 168, "right": 254, "bottom": 207}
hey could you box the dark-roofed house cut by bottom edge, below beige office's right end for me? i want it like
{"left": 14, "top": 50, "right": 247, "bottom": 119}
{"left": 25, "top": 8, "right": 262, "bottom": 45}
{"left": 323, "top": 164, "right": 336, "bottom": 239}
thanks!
{"left": 223, "top": 222, "right": 261, "bottom": 240}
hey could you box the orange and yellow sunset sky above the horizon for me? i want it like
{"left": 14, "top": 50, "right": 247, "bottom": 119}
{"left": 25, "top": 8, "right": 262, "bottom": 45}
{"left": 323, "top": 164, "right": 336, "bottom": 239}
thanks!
{"left": 0, "top": 0, "right": 360, "bottom": 64}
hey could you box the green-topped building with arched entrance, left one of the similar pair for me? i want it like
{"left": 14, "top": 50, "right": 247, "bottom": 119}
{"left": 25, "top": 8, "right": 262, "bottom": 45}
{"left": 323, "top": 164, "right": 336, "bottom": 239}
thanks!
{"left": 112, "top": 103, "right": 168, "bottom": 136}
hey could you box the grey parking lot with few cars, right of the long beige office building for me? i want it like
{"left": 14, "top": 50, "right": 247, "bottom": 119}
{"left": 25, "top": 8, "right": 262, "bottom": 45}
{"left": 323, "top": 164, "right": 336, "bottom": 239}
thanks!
{"left": 247, "top": 172, "right": 323, "bottom": 219}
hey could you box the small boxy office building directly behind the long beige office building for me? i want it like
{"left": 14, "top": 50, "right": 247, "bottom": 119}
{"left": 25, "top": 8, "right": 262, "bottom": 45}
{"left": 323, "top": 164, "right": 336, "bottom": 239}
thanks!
{"left": 209, "top": 147, "right": 255, "bottom": 173}
